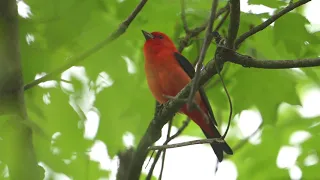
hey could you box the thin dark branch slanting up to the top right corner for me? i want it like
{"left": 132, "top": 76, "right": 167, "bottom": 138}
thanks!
{"left": 235, "top": 0, "right": 311, "bottom": 49}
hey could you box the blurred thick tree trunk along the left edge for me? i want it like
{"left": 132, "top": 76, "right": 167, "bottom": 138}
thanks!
{"left": 0, "top": 0, "right": 44, "bottom": 180}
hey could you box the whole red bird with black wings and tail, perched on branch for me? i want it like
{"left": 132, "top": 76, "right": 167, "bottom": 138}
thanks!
{"left": 142, "top": 30, "right": 233, "bottom": 162}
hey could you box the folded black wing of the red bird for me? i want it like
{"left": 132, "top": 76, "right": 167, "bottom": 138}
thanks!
{"left": 174, "top": 52, "right": 217, "bottom": 126}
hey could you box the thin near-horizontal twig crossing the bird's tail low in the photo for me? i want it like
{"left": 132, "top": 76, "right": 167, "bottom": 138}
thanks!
{"left": 149, "top": 138, "right": 225, "bottom": 150}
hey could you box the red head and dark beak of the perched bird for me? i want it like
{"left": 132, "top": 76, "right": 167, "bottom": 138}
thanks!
{"left": 142, "top": 30, "right": 176, "bottom": 53}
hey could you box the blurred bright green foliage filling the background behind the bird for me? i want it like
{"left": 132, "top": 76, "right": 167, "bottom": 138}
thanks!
{"left": 0, "top": 0, "right": 320, "bottom": 179}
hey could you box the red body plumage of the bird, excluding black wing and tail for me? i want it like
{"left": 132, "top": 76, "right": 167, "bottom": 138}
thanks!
{"left": 144, "top": 33, "right": 212, "bottom": 134}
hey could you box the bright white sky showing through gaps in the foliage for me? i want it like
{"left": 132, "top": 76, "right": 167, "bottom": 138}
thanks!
{"left": 18, "top": 0, "right": 320, "bottom": 180}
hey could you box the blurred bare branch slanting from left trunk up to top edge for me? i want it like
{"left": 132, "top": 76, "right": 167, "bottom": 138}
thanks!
{"left": 24, "top": 0, "right": 148, "bottom": 90}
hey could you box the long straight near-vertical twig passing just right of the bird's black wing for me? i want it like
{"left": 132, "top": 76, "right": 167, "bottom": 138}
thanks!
{"left": 187, "top": 0, "right": 218, "bottom": 109}
